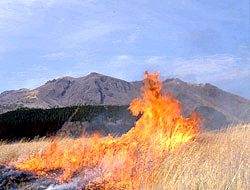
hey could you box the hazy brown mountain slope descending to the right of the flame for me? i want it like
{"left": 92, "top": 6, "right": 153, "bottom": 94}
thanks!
{"left": 160, "top": 79, "right": 250, "bottom": 129}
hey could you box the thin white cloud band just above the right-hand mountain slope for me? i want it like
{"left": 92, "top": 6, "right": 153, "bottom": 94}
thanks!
{"left": 172, "top": 54, "right": 250, "bottom": 82}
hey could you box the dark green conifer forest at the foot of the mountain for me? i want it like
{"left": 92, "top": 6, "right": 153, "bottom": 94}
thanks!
{"left": 0, "top": 105, "right": 135, "bottom": 141}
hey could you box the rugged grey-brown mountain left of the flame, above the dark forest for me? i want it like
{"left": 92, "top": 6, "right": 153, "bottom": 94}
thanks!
{"left": 0, "top": 73, "right": 141, "bottom": 113}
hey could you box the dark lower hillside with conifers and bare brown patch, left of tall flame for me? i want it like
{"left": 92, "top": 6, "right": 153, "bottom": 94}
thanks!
{"left": 0, "top": 105, "right": 139, "bottom": 141}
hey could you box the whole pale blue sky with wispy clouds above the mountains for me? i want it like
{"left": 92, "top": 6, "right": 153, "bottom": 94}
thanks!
{"left": 0, "top": 0, "right": 250, "bottom": 99}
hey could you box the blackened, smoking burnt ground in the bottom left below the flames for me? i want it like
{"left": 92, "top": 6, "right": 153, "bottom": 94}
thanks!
{"left": 0, "top": 165, "right": 109, "bottom": 190}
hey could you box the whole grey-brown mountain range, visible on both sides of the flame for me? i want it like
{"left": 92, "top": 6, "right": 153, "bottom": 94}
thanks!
{"left": 0, "top": 73, "right": 250, "bottom": 126}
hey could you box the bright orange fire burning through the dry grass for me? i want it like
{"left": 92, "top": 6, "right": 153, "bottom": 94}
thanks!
{"left": 15, "top": 72, "right": 199, "bottom": 189}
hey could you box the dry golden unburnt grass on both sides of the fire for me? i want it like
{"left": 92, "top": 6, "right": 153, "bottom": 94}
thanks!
{"left": 0, "top": 124, "right": 250, "bottom": 190}
